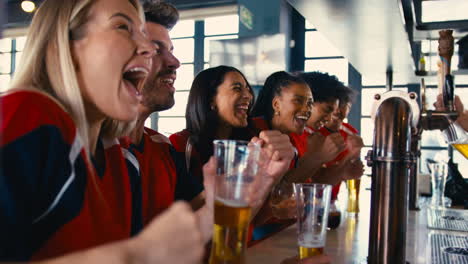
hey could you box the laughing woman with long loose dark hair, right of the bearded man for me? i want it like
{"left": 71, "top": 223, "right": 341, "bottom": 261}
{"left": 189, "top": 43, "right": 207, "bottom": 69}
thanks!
{"left": 169, "top": 66, "right": 294, "bottom": 182}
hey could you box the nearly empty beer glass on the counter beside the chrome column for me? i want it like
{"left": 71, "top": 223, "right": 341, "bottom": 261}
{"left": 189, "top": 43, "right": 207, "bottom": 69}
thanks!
{"left": 294, "top": 183, "right": 332, "bottom": 259}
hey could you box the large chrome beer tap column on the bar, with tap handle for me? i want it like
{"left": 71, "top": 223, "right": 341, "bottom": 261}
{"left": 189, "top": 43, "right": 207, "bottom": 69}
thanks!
{"left": 366, "top": 31, "right": 457, "bottom": 264}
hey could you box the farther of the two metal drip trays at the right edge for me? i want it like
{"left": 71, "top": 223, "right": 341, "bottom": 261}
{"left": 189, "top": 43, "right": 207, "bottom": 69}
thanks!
{"left": 427, "top": 210, "right": 468, "bottom": 232}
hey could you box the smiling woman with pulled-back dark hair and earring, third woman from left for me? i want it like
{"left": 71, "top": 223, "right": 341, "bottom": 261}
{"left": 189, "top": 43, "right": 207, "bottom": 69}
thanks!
{"left": 252, "top": 71, "right": 344, "bottom": 184}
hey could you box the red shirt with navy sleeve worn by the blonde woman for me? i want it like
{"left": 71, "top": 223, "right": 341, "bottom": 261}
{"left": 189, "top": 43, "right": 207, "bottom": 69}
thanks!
{"left": 0, "top": 91, "right": 142, "bottom": 261}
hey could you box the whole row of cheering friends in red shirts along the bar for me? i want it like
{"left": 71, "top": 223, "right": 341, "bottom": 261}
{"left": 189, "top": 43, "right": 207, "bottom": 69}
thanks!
{"left": 0, "top": 0, "right": 468, "bottom": 264}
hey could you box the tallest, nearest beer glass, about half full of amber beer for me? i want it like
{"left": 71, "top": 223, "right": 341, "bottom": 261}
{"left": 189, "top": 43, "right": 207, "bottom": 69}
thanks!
{"left": 209, "top": 140, "right": 260, "bottom": 264}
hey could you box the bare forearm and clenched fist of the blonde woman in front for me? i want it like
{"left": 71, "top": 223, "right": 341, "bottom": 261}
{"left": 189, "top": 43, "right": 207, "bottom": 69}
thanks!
{"left": 42, "top": 202, "right": 204, "bottom": 264}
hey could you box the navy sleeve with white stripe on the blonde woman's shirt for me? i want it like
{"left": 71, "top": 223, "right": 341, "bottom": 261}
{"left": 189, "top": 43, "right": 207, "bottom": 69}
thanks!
{"left": 0, "top": 125, "right": 86, "bottom": 261}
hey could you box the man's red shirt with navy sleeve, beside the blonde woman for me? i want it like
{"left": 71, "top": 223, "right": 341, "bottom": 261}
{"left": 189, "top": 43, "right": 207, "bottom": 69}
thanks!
{"left": 121, "top": 127, "right": 203, "bottom": 224}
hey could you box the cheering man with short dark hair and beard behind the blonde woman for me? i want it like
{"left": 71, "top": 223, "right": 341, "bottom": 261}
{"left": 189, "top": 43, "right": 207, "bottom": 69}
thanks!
{"left": 123, "top": 1, "right": 207, "bottom": 237}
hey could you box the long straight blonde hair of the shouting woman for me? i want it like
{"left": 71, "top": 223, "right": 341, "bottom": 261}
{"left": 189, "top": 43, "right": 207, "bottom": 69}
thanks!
{"left": 11, "top": 0, "right": 144, "bottom": 154}
